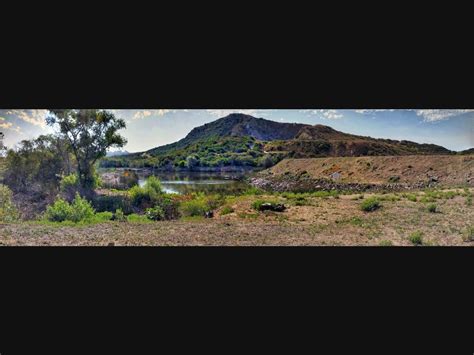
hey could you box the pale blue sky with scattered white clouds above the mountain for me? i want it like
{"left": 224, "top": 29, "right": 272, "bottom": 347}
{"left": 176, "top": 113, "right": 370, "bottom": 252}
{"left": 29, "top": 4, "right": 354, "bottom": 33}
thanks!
{"left": 0, "top": 109, "right": 474, "bottom": 152}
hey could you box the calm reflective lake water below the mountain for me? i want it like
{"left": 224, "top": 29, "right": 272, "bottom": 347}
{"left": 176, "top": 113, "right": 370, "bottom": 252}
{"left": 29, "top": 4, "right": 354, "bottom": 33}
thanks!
{"left": 138, "top": 171, "right": 252, "bottom": 194}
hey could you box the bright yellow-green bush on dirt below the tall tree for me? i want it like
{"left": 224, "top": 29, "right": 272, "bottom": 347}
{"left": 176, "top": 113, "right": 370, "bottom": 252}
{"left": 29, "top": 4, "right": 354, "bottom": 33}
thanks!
{"left": 45, "top": 194, "right": 96, "bottom": 223}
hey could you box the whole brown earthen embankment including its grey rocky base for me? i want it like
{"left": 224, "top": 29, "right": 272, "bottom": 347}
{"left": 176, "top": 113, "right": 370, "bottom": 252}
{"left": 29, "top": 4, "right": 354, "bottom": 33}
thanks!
{"left": 250, "top": 155, "right": 474, "bottom": 192}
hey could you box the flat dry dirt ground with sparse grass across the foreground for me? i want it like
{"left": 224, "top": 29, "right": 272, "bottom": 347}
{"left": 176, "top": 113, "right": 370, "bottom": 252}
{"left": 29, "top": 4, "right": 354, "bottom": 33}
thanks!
{"left": 0, "top": 189, "right": 474, "bottom": 246}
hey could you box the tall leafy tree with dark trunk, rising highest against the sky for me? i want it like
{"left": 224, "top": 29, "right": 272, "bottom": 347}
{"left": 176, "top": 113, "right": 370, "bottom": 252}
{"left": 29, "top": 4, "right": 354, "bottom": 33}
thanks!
{"left": 46, "top": 109, "right": 127, "bottom": 191}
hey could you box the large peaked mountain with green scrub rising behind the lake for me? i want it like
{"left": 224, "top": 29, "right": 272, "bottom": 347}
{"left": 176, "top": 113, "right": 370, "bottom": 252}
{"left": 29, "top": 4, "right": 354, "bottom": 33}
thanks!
{"left": 101, "top": 114, "right": 453, "bottom": 170}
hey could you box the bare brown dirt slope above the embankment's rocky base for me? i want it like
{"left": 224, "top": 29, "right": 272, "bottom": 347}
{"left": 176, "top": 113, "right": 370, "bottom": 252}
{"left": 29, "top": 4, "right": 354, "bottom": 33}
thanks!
{"left": 269, "top": 155, "right": 474, "bottom": 186}
